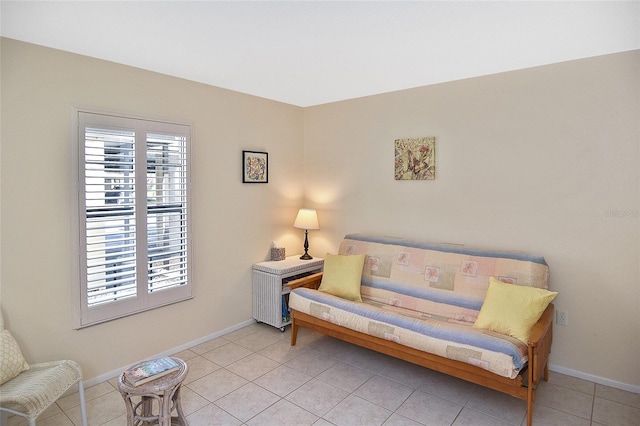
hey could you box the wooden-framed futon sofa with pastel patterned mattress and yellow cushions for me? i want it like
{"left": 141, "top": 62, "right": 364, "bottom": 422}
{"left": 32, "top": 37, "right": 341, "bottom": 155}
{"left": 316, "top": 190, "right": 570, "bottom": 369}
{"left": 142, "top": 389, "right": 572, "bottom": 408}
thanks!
{"left": 289, "top": 234, "right": 556, "bottom": 425}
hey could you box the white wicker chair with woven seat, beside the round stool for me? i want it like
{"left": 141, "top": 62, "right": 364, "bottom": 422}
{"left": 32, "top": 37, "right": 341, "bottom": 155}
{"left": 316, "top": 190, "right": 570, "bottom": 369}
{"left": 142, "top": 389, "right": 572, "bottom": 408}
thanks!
{"left": 0, "top": 312, "right": 87, "bottom": 426}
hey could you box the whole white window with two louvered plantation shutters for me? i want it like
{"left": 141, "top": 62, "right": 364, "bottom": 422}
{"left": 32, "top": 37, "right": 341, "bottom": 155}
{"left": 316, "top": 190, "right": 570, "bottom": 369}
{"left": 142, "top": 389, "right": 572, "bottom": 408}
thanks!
{"left": 74, "top": 111, "right": 192, "bottom": 328}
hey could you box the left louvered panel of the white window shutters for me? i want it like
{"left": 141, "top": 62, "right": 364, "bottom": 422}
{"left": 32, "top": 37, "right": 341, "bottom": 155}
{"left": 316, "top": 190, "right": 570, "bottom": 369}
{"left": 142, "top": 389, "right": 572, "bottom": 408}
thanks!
{"left": 84, "top": 127, "right": 137, "bottom": 308}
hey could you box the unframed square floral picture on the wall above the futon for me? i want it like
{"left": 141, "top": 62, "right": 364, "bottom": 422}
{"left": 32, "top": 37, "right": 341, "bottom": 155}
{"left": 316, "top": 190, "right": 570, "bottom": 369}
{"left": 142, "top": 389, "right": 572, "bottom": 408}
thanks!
{"left": 395, "top": 137, "right": 436, "bottom": 180}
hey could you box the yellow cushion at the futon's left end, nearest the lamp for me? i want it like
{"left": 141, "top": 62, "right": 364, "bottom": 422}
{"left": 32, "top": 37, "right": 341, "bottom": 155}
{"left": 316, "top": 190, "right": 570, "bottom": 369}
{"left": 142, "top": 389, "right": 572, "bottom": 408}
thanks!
{"left": 318, "top": 253, "right": 365, "bottom": 302}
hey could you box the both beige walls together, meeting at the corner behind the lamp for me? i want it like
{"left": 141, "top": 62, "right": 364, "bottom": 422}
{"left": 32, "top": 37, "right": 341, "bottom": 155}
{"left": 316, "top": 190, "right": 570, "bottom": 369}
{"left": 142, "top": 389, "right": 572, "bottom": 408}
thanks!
{"left": 0, "top": 39, "right": 640, "bottom": 387}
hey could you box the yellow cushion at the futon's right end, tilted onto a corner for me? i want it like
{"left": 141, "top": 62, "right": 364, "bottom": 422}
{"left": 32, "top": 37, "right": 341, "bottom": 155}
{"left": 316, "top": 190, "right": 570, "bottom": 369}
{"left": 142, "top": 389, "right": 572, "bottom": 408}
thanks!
{"left": 473, "top": 277, "right": 558, "bottom": 344}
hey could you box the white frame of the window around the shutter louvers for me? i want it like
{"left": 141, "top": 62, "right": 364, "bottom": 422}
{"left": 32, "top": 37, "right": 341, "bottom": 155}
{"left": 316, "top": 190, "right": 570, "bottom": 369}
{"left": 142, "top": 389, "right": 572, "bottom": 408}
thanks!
{"left": 71, "top": 107, "right": 195, "bottom": 329}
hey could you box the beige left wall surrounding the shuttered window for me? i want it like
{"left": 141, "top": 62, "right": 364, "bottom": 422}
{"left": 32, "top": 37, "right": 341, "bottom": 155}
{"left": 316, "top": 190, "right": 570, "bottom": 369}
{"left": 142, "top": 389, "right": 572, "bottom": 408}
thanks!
{"left": 0, "top": 39, "right": 303, "bottom": 379}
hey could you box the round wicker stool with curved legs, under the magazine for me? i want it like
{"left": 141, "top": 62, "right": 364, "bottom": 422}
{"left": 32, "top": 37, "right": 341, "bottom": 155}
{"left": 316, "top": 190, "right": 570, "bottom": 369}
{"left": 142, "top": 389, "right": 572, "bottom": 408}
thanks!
{"left": 118, "top": 358, "right": 189, "bottom": 426}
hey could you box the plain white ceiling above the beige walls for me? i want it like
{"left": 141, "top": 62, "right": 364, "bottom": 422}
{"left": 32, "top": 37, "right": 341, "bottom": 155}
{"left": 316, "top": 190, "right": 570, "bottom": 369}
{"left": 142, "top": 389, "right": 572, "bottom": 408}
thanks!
{"left": 0, "top": 0, "right": 640, "bottom": 107}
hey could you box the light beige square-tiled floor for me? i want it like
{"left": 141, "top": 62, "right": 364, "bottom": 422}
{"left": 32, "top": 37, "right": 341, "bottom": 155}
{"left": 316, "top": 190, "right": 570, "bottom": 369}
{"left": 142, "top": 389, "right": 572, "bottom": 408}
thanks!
{"left": 8, "top": 324, "right": 640, "bottom": 426}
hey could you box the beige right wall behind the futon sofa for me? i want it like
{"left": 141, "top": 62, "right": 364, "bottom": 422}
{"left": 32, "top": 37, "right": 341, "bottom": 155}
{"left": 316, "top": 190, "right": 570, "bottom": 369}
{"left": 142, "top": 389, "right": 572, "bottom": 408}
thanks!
{"left": 304, "top": 51, "right": 640, "bottom": 389}
